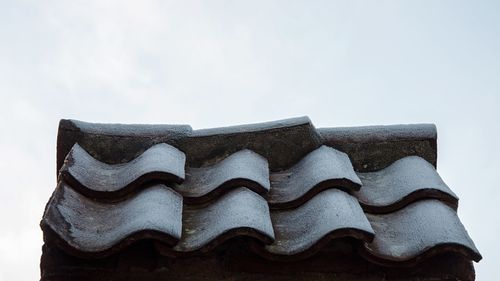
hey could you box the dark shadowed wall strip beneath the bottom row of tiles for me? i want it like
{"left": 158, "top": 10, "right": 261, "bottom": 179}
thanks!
{"left": 41, "top": 242, "right": 474, "bottom": 281}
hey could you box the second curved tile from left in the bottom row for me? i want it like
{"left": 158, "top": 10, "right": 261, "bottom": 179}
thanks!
{"left": 159, "top": 187, "right": 274, "bottom": 255}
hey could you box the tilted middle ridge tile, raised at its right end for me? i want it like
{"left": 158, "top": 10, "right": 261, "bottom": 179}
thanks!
{"left": 179, "top": 117, "right": 321, "bottom": 171}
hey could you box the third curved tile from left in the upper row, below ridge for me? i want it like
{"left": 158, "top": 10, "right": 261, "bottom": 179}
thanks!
{"left": 267, "top": 146, "right": 361, "bottom": 209}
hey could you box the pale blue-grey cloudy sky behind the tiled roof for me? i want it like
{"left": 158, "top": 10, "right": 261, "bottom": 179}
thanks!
{"left": 0, "top": 0, "right": 500, "bottom": 280}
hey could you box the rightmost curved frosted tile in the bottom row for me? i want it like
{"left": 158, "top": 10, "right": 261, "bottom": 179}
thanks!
{"left": 362, "top": 199, "right": 481, "bottom": 266}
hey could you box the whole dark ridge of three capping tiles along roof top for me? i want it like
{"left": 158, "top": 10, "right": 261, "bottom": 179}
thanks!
{"left": 57, "top": 117, "right": 437, "bottom": 172}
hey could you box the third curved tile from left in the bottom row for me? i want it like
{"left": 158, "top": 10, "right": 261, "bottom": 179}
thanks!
{"left": 256, "top": 189, "right": 373, "bottom": 260}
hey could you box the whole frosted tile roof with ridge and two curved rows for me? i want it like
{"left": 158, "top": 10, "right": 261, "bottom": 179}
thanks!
{"left": 41, "top": 117, "right": 481, "bottom": 280}
